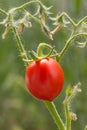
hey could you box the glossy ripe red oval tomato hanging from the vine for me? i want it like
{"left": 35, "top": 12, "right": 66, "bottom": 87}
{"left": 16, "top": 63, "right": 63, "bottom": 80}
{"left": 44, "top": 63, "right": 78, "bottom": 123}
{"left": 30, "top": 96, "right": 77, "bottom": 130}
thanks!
{"left": 25, "top": 58, "right": 64, "bottom": 101}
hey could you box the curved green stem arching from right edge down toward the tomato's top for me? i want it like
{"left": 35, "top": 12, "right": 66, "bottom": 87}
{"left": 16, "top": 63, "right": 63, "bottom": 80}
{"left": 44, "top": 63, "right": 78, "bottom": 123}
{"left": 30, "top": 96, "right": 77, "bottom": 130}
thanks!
{"left": 59, "top": 33, "right": 87, "bottom": 60}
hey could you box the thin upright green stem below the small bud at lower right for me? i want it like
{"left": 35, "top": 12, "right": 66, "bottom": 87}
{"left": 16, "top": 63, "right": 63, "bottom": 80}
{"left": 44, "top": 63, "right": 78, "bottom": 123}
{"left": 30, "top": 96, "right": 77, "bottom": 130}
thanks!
{"left": 64, "top": 101, "right": 71, "bottom": 130}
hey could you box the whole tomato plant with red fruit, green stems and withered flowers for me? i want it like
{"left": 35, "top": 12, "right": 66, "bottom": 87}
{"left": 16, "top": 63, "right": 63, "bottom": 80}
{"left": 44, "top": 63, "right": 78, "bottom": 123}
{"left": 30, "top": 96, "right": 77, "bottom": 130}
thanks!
{"left": 0, "top": 0, "right": 87, "bottom": 130}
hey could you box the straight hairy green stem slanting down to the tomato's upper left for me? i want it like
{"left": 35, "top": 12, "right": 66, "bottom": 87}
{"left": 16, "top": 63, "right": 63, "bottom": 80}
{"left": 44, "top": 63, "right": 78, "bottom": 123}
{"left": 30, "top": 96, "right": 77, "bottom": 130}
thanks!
{"left": 13, "top": 27, "right": 28, "bottom": 66}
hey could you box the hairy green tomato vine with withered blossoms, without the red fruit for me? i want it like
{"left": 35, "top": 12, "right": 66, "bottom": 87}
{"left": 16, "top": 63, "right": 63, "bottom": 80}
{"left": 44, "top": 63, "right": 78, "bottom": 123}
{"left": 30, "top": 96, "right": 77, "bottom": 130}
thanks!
{"left": 0, "top": 0, "right": 87, "bottom": 130}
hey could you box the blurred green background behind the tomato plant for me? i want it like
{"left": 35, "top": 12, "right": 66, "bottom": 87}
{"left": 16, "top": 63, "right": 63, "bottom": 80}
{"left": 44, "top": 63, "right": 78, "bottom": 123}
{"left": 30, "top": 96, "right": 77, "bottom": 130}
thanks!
{"left": 0, "top": 0, "right": 87, "bottom": 130}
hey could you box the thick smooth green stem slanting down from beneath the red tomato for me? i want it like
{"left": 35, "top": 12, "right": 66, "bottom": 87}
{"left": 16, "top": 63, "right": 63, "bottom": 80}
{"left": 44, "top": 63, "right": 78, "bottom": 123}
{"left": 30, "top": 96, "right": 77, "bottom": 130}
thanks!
{"left": 44, "top": 101, "right": 65, "bottom": 130}
